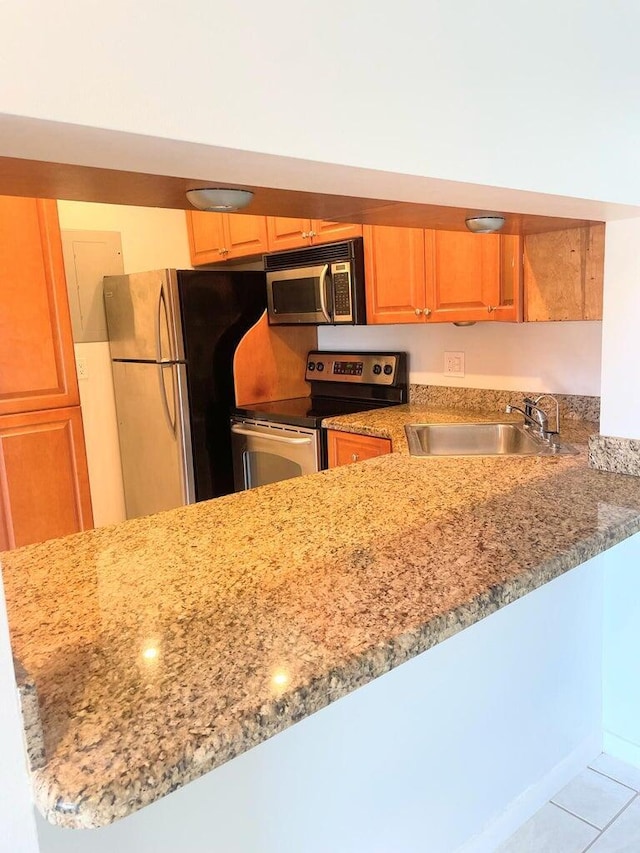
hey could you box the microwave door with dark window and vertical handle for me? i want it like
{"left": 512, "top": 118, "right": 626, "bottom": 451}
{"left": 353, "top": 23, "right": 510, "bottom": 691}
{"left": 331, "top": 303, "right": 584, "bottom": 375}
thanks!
{"left": 267, "top": 264, "right": 333, "bottom": 325}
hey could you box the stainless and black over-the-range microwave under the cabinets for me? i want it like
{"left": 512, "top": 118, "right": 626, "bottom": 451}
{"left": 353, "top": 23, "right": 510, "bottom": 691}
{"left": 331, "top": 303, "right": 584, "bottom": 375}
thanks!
{"left": 264, "top": 237, "right": 367, "bottom": 326}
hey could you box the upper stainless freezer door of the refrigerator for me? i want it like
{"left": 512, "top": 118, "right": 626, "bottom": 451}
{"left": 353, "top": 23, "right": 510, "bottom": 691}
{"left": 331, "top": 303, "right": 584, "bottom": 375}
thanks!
{"left": 103, "top": 270, "right": 184, "bottom": 361}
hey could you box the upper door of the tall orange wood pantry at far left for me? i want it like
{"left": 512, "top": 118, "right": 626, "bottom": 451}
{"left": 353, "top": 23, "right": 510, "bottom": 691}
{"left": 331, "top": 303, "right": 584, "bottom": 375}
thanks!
{"left": 0, "top": 196, "right": 79, "bottom": 415}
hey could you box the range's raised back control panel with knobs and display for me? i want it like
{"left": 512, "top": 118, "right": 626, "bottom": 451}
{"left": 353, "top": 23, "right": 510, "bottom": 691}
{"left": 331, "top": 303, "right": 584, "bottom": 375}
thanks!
{"left": 304, "top": 351, "right": 400, "bottom": 385}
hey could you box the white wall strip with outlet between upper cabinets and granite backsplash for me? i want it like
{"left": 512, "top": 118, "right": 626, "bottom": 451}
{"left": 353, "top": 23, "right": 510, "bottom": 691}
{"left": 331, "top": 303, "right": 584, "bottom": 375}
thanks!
{"left": 318, "top": 322, "right": 602, "bottom": 396}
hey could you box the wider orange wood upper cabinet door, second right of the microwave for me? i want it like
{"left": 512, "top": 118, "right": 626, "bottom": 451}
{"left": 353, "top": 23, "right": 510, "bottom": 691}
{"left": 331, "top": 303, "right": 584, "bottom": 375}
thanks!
{"left": 425, "top": 230, "right": 521, "bottom": 323}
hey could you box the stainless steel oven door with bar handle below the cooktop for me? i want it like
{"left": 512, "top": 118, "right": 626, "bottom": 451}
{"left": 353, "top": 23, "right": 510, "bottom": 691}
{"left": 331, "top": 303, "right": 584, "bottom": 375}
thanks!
{"left": 231, "top": 418, "right": 320, "bottom": 492}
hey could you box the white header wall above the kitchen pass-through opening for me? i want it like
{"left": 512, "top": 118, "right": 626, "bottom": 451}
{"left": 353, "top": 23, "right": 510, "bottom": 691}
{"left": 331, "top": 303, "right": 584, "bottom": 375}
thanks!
{"left": 0, "top": 5, "right": 640, "bottom": 213}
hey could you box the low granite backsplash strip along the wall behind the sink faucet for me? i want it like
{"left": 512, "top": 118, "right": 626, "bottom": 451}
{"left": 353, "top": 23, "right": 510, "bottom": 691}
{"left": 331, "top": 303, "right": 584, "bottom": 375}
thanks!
{"left": 409, "top": 385, "right": 600, "bottom": 425}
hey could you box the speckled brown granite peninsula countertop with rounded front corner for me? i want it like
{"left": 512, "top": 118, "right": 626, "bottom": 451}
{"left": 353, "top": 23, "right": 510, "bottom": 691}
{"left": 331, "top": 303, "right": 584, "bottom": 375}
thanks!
{"left": 0, "top": 407, "right": 640, "bottom": 827}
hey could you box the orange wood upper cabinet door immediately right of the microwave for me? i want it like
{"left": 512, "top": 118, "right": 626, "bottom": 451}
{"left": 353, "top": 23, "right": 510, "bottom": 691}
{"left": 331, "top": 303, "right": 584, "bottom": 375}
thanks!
{"left": 363, "top": 225, "right": 427, "bottom": 323}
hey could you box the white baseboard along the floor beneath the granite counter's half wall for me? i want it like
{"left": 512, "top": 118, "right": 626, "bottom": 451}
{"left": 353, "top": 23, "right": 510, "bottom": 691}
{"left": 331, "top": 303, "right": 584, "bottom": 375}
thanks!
{"left": 456, "top": 731, "right": 604, "bottom": 853}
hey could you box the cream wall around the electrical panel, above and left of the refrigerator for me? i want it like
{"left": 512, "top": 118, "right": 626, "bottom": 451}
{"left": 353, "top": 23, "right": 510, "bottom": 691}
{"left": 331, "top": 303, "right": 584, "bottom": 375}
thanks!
{"left": 58, "top": 201, "right": 191, "bottom": 527}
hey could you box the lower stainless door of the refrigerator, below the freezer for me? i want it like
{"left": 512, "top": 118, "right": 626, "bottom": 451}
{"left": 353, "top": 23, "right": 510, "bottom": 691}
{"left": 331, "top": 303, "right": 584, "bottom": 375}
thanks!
{"left": 112, "top": 361, "right": 194, "bottom": 518}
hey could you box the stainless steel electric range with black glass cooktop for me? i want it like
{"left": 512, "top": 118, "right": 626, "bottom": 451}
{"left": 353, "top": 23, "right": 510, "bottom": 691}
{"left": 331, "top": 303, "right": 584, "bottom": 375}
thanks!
{"left": 231, "top": 350, "right": 408, "bottom": 491}
